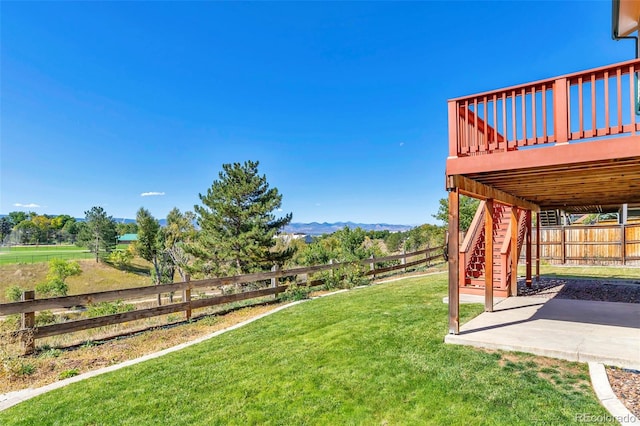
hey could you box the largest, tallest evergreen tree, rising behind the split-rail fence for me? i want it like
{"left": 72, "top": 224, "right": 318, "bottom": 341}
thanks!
{"left": 189, "top": 161, "right": 292, "bottom": 276}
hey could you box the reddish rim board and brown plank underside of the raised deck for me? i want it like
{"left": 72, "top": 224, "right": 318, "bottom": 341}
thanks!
{"left": 447, "top": 136, "right": 640, "bottom": 212}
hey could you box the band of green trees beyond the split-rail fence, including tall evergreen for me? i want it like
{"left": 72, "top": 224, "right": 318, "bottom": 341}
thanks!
{"left": 0, "top": 161, "right": 480, "bottom": 294}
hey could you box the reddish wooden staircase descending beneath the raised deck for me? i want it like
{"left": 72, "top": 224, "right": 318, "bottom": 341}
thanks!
{"left": 460, "top": 202, "right": 526, "bottom": 297}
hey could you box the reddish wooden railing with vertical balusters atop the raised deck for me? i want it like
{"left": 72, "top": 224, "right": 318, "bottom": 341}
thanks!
{"left": 448, "top": 59, "right": 640, "bottom": 157}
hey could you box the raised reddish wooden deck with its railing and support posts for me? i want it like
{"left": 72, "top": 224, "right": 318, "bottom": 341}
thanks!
{"left": 446, "top": 59, "right": 640, "bottom": 334}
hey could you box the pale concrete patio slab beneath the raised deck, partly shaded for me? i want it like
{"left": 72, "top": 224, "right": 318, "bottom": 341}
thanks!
{"left": 445, "top": 297, "right": 640, "bottom": 370}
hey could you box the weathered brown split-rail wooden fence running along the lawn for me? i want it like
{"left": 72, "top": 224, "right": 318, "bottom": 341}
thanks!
{"left": 0, "top": 247, "right": 443, "bottom": 354}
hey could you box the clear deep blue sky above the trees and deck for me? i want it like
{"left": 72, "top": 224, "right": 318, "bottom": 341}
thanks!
{"left": 0, "top": 1, "right": 634, "bottom": 225}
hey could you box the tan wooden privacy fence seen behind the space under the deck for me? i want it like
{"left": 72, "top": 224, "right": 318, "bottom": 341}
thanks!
{"left": 533, "top": 224, "right": 640, "bottom": 265}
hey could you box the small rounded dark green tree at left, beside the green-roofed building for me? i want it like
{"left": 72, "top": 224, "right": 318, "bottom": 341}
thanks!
{"left": 77, "top": 207, "right": 118, "bottom": 262}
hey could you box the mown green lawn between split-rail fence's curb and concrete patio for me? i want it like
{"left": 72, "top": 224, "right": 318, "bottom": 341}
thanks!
{"left": 0, "top": 274, "right": 607, "bottom": 425}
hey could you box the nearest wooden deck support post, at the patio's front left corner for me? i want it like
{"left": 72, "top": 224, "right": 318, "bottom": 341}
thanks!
{"left": 447, "top": 187, "right": 460, "bottom": 334}
